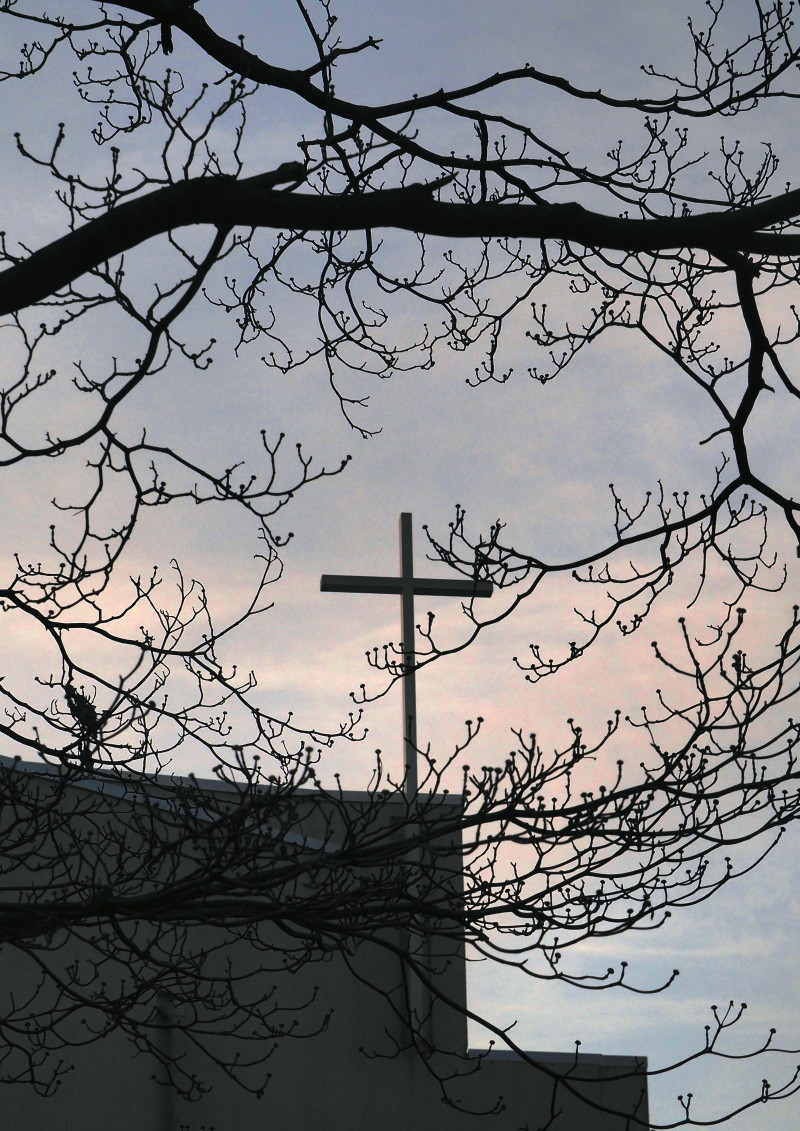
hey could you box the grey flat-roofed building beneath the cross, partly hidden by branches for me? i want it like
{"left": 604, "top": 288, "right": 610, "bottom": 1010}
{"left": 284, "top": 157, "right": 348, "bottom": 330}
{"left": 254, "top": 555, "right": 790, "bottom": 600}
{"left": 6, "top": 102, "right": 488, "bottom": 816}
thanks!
{"left": 0, "top": 760, "right": 647, "bottom": 1131}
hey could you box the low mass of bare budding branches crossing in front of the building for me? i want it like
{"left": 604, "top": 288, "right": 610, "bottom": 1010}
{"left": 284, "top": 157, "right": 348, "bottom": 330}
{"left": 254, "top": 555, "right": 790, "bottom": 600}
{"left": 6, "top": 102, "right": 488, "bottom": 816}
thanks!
{"left": 0, "top": 610, "right": 800, "bottom": 1125}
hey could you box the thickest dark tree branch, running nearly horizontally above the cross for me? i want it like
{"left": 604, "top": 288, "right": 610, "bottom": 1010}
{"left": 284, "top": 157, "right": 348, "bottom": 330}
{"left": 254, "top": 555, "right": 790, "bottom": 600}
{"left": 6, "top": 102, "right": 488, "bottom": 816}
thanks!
{"left": 0, "top": 176, "right": 800, "bottom": 314}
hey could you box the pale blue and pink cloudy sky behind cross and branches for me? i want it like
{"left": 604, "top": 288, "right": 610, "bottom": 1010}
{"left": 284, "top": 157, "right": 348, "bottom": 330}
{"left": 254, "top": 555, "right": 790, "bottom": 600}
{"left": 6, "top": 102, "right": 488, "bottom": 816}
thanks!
{"left": 0, "top": 0, "right": 800, "bottom": 1131}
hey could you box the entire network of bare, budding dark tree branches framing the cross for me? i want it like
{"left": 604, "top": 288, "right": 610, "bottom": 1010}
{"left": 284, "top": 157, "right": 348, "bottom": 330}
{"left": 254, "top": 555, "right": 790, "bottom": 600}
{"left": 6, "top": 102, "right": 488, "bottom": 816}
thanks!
{"left": 0, "top": 0, "right": 800, "bottom": 1125}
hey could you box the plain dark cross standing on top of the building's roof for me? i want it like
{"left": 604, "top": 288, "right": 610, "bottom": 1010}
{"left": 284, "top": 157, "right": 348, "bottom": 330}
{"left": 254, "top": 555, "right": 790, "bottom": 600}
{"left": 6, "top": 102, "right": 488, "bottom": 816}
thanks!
{"left": 319, "top": 511, "right": 492, "bottom": 798}
